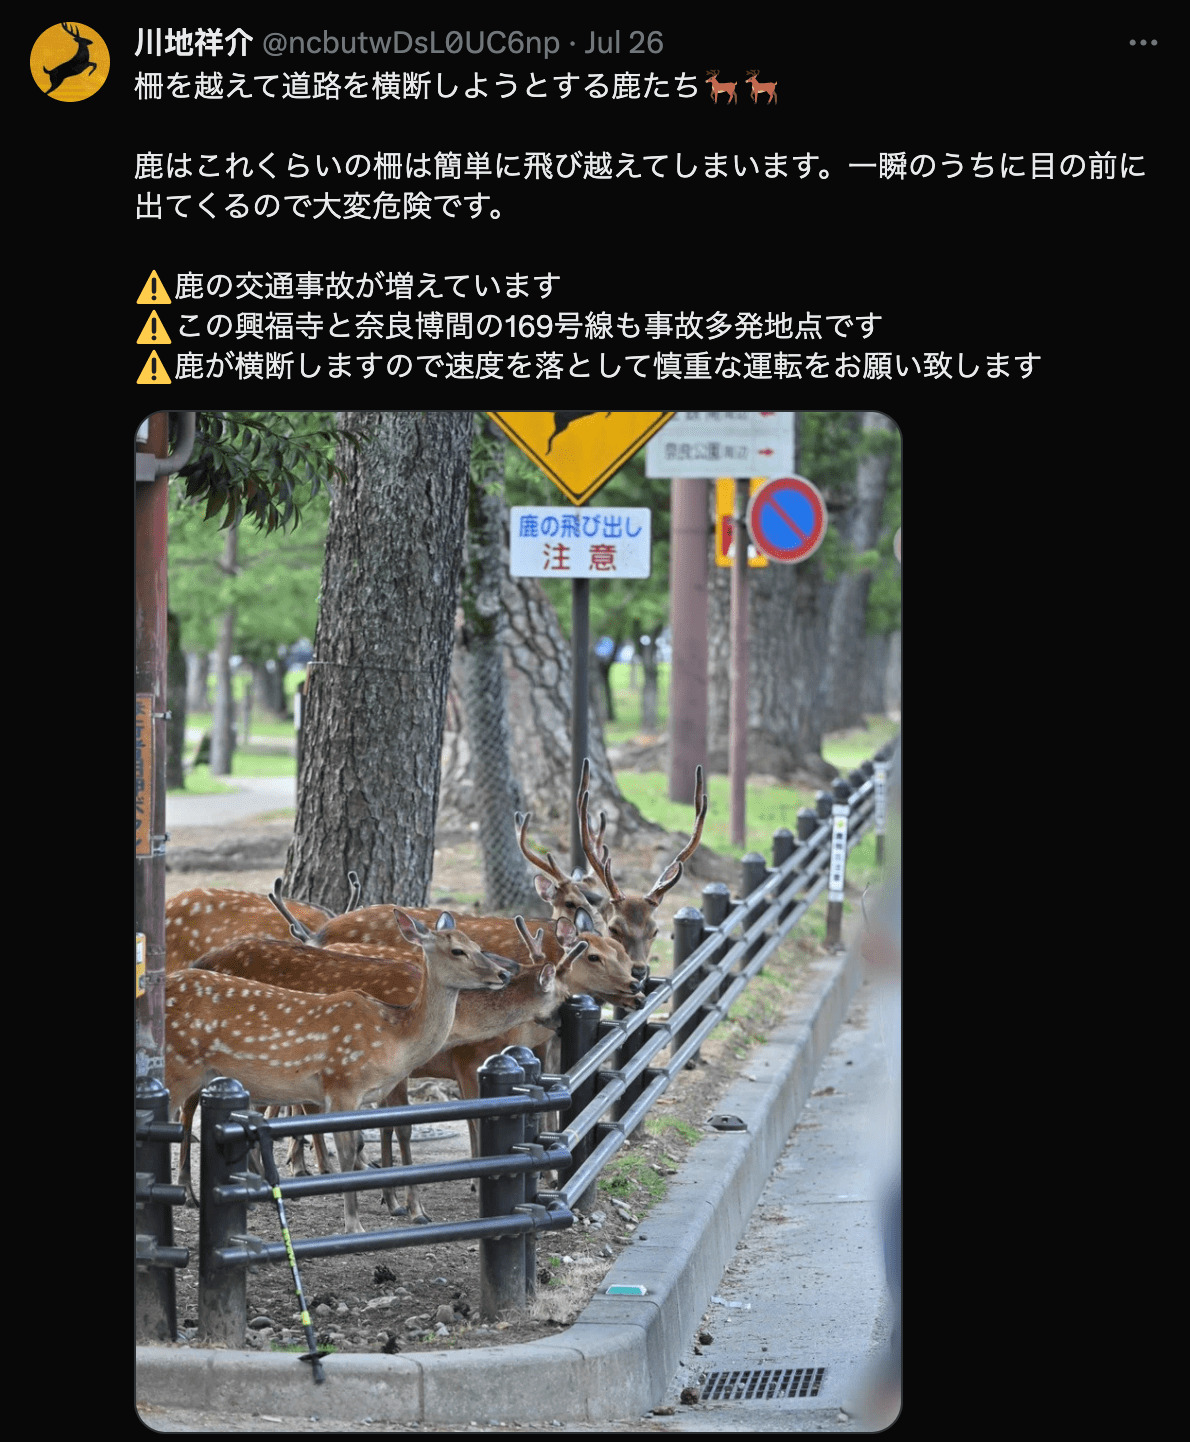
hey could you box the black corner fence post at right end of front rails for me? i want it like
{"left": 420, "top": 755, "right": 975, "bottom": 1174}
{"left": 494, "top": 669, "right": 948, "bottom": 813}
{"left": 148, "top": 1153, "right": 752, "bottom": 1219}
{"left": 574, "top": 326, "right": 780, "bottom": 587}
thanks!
{"left": 479, "top": 1051, "right": 525, "bottom": 1322}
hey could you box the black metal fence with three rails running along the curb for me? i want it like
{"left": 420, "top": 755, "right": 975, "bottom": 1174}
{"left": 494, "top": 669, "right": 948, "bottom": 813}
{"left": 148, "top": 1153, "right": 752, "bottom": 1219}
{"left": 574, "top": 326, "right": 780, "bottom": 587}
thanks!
{"left": 136, "top": 741, "right": 896, "bottom": 1345}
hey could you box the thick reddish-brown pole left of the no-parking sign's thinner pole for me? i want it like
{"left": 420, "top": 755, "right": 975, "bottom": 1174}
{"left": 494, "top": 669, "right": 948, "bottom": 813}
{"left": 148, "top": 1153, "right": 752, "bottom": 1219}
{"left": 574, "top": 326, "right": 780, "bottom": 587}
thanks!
{"left": 669, "top": 480, "right": 708, "bottom": 802}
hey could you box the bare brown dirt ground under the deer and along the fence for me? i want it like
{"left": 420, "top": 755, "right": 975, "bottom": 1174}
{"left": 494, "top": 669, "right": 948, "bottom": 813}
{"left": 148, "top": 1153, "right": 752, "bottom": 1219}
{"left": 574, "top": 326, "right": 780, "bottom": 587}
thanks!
{"left": 152, "top": 820, "right": 819, "bottom": 1353}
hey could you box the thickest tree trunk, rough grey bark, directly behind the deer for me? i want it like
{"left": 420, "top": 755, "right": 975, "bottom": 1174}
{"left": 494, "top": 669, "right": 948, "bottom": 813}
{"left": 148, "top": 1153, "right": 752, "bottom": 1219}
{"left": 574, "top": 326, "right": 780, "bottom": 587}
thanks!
{"left": 286, "top": 411, "right": 472, "bottom": 908}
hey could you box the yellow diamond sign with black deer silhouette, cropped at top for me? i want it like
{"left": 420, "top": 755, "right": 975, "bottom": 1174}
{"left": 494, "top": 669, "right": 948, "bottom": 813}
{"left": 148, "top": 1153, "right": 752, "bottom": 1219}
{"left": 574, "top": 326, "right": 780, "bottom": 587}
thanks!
{"left": 488, "top": 411, "right": 674, "bottom": 506}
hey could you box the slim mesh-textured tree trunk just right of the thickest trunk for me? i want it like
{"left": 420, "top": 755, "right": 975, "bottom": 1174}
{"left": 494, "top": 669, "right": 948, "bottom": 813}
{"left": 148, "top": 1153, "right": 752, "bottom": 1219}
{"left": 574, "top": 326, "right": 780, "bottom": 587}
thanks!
{"left": 456, "top": 421, "right": 539, "bottom": 913}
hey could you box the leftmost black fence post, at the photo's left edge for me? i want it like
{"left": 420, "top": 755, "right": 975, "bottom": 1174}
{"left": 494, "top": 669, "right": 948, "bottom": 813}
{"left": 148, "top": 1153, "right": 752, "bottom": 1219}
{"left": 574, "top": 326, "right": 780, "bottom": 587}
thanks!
{"left": 134, "top": 1076, "right": 185, "bottom": 1343}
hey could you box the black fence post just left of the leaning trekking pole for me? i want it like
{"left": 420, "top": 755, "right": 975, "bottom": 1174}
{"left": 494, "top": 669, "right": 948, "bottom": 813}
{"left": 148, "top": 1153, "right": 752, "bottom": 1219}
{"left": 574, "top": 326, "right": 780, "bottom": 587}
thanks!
{"left": 199, "top": 1077, "right": 250, "bottom": 1347}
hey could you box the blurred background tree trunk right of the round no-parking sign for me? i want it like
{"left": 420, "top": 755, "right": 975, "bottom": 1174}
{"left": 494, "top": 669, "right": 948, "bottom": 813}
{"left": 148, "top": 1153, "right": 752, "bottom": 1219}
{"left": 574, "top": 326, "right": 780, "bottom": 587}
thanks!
{"left": 822, "top": 411, "right": 894, "bottom": 731}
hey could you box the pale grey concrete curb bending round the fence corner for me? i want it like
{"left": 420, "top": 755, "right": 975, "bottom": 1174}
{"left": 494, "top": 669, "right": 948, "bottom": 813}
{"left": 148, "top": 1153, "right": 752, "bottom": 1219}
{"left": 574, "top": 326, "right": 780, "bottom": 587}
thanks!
{"left": 136, "top": 952, "right": 863, "bottom": 1426}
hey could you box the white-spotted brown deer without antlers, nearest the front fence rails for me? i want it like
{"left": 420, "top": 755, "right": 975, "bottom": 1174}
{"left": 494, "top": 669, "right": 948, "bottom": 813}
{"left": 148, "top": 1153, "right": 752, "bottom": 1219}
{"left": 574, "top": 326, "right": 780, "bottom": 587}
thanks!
{"left": 166, "top": 907, "right": 512, "bottom": 1231}
